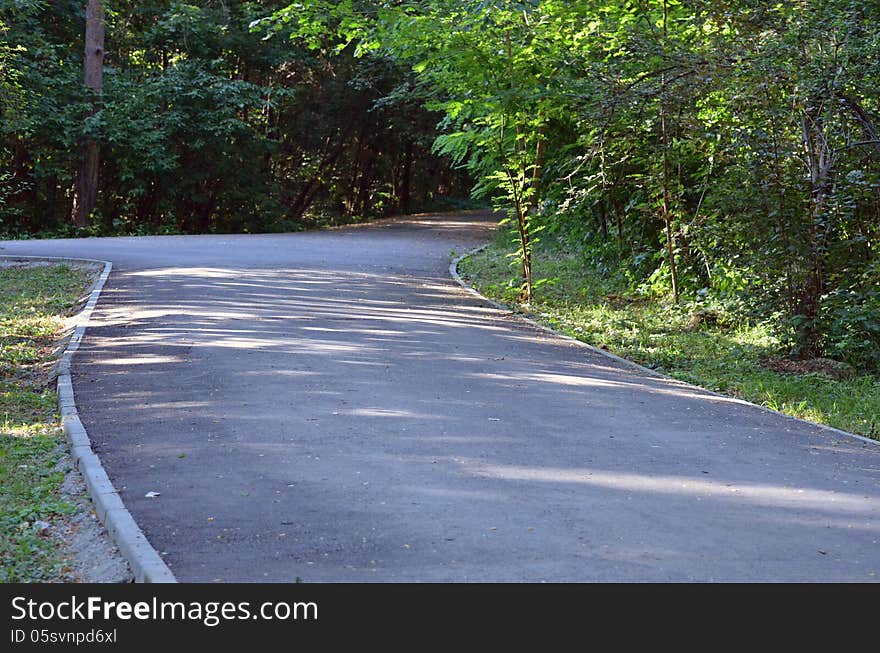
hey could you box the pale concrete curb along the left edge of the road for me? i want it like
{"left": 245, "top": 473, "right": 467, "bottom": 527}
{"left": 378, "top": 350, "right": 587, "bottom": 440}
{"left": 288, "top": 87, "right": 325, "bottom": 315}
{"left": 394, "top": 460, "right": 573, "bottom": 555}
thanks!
{"left": 0, "top": 255, "right": 177, "bottom": 583}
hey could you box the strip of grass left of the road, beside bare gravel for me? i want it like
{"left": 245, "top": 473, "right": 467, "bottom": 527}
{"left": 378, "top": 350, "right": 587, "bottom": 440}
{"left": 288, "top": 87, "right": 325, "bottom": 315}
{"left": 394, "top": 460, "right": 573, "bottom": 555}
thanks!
{"left": 0, "top": 265, "right": 91, "bottom": 582}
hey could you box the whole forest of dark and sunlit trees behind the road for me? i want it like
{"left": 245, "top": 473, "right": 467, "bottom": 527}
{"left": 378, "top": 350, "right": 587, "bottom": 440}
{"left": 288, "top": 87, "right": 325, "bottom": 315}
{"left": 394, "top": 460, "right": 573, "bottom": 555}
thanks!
{"left": 0, "top": 0, "right": 880, "bottom": 371}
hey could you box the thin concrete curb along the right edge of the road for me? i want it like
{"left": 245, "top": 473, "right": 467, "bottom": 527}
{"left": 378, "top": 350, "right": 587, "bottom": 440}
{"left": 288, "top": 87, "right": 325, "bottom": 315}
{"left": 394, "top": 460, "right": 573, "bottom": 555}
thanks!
{"left": 449, "top": 244, "right": 880, "bottom": 446}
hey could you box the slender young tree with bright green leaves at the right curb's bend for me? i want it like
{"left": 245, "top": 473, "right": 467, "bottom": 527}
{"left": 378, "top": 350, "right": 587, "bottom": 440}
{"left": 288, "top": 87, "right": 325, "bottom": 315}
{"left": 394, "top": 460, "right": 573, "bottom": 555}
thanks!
{"left": 375, "top": 0, "right": 565, "bottom": 302}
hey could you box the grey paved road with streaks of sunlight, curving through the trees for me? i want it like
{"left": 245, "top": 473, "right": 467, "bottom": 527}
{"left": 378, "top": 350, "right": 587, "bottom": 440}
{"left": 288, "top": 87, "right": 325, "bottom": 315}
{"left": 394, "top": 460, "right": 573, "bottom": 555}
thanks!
{"left": 0, "top": 216, "right": 880, "bottom": 582}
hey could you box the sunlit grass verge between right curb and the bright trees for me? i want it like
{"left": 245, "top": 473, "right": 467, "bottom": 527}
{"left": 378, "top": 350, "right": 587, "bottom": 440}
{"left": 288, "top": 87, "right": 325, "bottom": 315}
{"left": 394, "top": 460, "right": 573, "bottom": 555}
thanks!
{"left": 460, "top": 232, "right": 880, "bottom": 439}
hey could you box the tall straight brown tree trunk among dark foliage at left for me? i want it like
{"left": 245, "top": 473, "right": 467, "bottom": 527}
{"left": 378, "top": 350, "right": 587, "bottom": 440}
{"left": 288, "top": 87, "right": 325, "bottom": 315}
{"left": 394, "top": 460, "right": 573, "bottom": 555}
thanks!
{"left": 71, "top": 0, "right": 104, "bottom": 227}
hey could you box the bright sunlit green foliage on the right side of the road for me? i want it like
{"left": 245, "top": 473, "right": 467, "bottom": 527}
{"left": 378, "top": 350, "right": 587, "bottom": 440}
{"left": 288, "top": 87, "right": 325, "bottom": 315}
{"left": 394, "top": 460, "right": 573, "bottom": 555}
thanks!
{"left": 360, "top": 0, "right": 880, "bottom": 369}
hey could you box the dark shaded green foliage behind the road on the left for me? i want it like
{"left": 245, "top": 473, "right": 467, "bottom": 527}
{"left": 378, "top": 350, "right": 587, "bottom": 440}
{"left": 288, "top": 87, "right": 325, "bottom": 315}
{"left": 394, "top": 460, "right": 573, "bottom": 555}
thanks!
{"left": 0, "top": 0, "right": 468, "bottom": 237}
